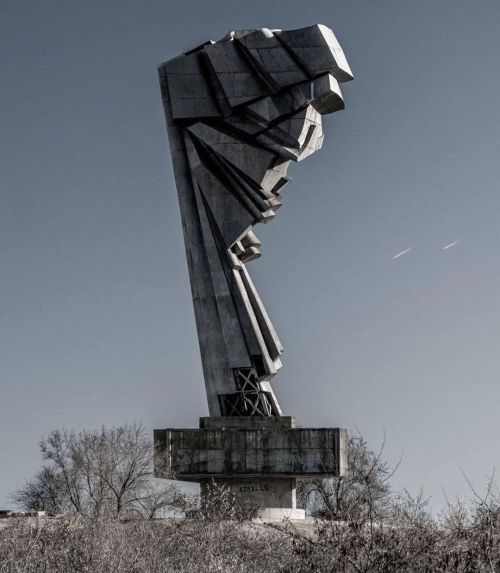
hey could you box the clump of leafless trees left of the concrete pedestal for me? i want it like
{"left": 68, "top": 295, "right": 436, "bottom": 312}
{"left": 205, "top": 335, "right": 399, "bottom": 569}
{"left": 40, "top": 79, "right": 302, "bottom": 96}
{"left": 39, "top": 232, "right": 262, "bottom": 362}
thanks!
{"left": 12, "top": 423, "right": 182, "bottom": 517}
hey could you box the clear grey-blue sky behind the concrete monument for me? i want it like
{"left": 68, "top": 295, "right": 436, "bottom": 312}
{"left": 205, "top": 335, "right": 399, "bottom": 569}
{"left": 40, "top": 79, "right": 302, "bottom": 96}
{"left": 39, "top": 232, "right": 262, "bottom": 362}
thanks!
{"left": 0, "top": 0, "right": 500, "bottom": 506}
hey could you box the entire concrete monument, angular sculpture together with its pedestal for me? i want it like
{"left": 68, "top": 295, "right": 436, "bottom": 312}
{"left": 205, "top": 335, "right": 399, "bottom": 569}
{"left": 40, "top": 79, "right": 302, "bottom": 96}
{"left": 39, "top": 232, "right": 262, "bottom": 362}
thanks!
{"left": 155, "top": 25, "right": 352, "bottom": 515}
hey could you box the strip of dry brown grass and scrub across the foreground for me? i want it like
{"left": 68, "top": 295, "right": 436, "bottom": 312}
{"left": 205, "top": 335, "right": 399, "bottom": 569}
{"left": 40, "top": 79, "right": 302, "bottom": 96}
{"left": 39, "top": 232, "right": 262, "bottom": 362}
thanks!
{"left": 0, "top": 498, "right": 500, "bottom": 573}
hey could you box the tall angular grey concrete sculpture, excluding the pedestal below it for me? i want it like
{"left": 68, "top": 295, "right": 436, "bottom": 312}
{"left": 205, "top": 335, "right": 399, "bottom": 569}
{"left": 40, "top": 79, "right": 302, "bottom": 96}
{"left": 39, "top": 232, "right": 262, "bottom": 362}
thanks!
{"left": 160, "top": 25, "right": 352, "bottom": 416}
